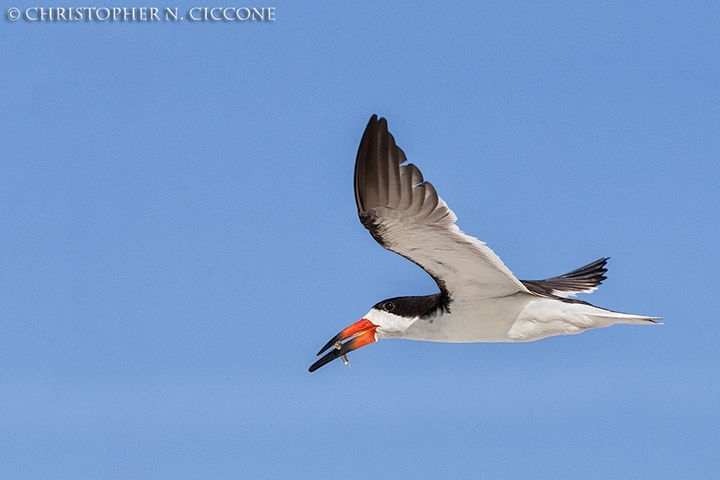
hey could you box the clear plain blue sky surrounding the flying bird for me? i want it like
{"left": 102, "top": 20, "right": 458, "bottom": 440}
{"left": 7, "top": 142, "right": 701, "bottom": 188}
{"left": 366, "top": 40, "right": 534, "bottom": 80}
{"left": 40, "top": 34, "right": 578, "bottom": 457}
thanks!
{"left": 0, "top": 0, "right": 720, "bottom": 479}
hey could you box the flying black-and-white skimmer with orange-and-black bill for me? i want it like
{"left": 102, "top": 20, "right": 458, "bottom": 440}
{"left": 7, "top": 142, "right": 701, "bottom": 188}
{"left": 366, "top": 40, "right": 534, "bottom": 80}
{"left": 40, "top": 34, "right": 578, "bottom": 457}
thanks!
{"left": 309, "top": 115, "right": 659, "bottom": 372}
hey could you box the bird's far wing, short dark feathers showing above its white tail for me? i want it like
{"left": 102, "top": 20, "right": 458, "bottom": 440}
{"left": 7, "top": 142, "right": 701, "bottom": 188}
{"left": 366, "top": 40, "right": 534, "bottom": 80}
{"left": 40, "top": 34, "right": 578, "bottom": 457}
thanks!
{"left": 521, "top": 258, "right": 608, "bottom": 298}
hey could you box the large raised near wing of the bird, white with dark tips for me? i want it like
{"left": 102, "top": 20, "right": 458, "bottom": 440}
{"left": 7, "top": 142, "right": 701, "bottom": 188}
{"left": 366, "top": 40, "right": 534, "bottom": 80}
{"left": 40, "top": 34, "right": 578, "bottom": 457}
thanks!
{"left": 355, "top": 115, "right": 529, "bottom": 300}
